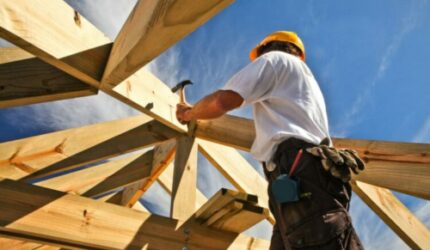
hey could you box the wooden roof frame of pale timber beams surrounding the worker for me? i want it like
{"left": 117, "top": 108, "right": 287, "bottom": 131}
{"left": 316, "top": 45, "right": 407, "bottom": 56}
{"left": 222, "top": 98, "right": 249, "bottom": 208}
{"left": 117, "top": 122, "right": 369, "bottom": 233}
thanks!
{"left": 0, "top": 0, "right": 430, "bottom": 249}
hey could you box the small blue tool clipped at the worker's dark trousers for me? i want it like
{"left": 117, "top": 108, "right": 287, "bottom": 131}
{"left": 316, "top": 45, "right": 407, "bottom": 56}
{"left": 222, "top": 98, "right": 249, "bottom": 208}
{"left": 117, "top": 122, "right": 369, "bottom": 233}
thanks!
{"left": 272, "top": 174, "right": 300, "bottom": 203}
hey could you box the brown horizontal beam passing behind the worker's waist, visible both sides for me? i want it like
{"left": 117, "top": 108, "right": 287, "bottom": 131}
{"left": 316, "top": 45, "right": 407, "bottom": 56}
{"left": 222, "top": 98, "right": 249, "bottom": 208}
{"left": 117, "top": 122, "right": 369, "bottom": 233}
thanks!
{"left": 196, "top": 115, "right": 430, "bottom": 199}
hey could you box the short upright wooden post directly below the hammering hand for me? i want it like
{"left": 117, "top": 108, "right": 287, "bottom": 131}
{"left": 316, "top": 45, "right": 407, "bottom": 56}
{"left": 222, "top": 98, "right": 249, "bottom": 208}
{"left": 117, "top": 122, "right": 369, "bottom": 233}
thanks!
{"left": 170, "top": 136, "right": 197, "bottom": 220}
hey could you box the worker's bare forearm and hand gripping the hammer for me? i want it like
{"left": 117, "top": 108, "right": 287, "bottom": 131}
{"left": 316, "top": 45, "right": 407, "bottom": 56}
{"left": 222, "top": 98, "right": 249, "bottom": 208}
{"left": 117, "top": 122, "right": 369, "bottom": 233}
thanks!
{"left": 176, "top": 90, "right": 243, "bottom": 123}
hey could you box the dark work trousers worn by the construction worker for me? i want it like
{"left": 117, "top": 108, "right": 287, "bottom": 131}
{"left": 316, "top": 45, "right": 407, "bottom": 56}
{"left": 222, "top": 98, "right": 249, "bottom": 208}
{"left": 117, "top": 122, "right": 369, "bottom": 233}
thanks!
{"left": 264, "top": 138, "right": 363, "bottom": 250}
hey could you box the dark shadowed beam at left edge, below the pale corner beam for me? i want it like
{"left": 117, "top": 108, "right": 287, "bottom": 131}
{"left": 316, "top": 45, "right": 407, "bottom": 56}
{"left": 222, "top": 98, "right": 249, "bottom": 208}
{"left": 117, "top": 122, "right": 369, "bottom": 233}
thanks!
{"left": 0, "top": 48, "right": 98, "bottom": 108}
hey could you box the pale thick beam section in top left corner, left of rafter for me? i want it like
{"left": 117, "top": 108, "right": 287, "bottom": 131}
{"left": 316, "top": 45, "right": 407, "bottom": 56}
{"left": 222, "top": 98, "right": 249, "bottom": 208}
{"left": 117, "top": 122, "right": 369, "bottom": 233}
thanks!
{"left": 0, "top": 0, "right": 111, "bottom": 87}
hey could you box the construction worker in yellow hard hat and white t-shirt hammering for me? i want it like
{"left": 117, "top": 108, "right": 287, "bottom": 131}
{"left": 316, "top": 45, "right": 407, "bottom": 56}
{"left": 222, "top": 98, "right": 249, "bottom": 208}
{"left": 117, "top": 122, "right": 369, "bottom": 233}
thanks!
{"left": 176, "top": 31, "right": 364, "bottom": 249}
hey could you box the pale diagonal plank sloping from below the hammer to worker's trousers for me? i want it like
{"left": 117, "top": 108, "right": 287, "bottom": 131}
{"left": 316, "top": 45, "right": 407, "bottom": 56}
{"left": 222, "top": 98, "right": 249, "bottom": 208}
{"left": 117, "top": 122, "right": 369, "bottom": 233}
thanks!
{"left": 198, "top": 139, "right": 275, "bottom": 224}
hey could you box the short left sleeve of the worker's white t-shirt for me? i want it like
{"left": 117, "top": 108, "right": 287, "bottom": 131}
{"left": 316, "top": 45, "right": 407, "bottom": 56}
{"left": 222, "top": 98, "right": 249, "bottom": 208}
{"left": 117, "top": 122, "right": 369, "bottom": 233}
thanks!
{"left": 221, "top": 56, "right": 276, "bottom": 105}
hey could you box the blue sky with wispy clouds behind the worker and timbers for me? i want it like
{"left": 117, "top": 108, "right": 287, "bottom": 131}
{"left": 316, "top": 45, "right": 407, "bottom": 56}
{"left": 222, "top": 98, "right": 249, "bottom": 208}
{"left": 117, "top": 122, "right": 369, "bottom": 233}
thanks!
{"left": 0, "top": 0, "right": 430, "bottom": 249}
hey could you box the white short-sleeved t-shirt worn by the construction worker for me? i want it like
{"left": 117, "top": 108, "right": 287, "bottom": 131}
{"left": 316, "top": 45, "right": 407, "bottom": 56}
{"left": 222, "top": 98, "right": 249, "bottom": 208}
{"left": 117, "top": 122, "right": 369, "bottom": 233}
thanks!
{"left": 222, "top": 51, "right": 329, "bottom": 162}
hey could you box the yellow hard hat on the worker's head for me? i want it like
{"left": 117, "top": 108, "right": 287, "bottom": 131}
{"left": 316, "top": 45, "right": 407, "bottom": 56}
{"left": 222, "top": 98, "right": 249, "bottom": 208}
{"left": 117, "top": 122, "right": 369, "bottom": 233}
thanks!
{"left": 249, "top": 31, "right": 306, "bottom": 61}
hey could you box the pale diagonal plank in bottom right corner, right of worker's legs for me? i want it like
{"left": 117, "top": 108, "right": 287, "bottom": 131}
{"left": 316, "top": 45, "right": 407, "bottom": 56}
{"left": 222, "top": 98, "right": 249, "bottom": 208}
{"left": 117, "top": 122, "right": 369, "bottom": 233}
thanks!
{"left": 352, "top": 181, "right": 430, "bottom": 249}
